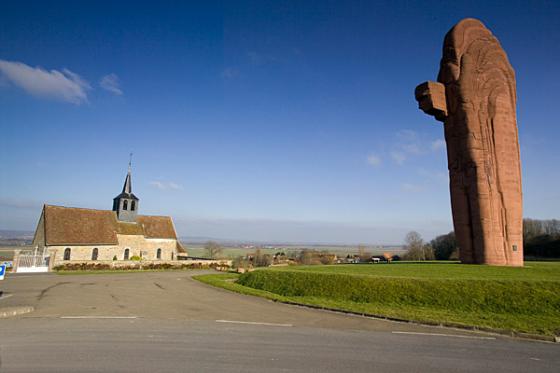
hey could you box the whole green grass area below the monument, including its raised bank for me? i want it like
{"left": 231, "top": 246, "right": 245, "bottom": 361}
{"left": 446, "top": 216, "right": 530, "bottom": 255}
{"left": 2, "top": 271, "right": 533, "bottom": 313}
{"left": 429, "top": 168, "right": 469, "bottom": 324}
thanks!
{"left": 195, "top": 262, "right": 560, "bottom": 336}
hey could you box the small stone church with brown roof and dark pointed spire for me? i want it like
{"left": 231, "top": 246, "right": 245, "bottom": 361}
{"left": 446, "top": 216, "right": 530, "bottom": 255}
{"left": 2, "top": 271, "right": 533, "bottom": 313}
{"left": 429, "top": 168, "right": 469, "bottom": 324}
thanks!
{"left": 33, "top": 165, "right": 186, "bottom": 265}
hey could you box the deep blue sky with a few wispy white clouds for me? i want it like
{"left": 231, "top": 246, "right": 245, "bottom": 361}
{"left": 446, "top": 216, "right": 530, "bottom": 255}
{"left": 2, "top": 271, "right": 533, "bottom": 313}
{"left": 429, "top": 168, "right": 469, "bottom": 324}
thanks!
{"left": 0, "top": 1, "right": 560, "bottom": 243}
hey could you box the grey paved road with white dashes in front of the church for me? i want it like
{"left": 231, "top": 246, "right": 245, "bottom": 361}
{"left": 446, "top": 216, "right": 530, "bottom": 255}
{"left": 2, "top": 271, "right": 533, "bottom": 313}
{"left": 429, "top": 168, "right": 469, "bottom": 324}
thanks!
{"left": 0, "top": 272, "right": 560, "bottom": 372}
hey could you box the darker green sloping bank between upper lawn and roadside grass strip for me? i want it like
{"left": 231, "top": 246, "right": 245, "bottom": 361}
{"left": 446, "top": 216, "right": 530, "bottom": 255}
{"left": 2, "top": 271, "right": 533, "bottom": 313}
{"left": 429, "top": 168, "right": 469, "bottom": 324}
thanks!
{"left": 238, "top": 270, "right": 560, "bottom": 317}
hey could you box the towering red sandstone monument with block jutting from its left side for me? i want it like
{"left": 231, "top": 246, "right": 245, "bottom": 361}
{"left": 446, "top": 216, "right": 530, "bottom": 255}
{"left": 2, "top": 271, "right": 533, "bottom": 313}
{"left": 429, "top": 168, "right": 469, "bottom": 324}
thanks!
{"left": 415, "top": 18, "right": 523, "bottom": 266}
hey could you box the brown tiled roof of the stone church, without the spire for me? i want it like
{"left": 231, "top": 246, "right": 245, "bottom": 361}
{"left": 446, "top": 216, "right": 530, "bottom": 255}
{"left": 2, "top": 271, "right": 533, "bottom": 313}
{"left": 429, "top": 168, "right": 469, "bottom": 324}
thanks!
{"left": 43, "top": 205, "right": 184, "bottom": 247}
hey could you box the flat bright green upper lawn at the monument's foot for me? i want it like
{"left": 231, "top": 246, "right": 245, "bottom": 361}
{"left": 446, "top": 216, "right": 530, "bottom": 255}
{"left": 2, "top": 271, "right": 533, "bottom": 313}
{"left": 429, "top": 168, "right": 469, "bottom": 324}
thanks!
{"left": 271, "top": 262, "right": 560, "bottom": 281}
